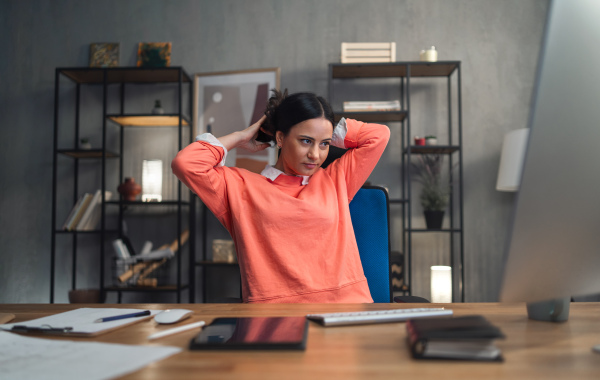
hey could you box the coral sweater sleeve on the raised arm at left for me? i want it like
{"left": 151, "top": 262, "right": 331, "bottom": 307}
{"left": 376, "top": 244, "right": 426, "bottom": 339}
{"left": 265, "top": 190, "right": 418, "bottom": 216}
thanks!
{"left": 171, "top": 140, "right": 230, "bottom": 229}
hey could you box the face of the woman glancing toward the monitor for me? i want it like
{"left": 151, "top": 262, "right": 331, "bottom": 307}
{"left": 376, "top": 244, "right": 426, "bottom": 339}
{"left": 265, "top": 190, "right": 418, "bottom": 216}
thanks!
{"left": 275, "top": 118, "right": 333, "bottom": 176}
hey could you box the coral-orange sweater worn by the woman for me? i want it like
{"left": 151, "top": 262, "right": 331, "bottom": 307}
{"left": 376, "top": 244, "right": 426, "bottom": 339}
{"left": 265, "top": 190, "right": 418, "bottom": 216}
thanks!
{"left": 171, "top": 119, "right": 390, "bottom": 303}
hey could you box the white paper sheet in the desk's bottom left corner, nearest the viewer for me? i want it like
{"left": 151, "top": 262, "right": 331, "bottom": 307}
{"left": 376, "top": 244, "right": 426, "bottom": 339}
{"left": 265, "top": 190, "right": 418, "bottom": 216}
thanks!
{"left": 0, "top": 331, "right": 181, "bottom": 380}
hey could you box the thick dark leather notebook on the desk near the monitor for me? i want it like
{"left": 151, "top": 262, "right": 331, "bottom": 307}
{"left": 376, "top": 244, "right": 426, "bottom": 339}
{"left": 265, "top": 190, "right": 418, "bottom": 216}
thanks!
{"left": 406, "top": 315, "right": 504, "bottom": 361}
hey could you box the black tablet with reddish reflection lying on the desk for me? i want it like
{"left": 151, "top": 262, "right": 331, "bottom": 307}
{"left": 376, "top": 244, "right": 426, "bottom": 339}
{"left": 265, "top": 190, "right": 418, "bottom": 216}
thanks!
{"left": 190, "top": 317, "right": 308, "bottom": 350}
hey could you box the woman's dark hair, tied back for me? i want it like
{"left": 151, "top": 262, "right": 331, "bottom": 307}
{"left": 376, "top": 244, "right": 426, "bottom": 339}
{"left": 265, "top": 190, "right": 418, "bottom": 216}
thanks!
{"left": 262, "top": 89, "right": 334, "bottom": 141}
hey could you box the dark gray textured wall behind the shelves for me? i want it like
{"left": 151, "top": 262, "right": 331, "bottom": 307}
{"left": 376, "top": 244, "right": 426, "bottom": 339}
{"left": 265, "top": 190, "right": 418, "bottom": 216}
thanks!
{"left": 0, "top": 0, "right": 547, "bottom": 303}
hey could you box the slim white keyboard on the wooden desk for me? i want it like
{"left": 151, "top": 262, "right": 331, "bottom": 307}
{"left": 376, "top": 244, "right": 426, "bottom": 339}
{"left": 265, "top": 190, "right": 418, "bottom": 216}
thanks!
{"left": 306, "top": 307, "right": 452, "bottom": 326}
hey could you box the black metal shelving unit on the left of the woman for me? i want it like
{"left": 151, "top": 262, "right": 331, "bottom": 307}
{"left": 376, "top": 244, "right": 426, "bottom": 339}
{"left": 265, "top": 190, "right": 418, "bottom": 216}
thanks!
{"left": 50, "top": 67, "right": 195, "bottom": 303}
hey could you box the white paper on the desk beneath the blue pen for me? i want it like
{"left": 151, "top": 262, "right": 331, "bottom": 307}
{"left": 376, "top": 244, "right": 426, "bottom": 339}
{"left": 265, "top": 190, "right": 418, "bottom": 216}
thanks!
{"left": 0, "top": 308, "right": 162, "bottom": 334}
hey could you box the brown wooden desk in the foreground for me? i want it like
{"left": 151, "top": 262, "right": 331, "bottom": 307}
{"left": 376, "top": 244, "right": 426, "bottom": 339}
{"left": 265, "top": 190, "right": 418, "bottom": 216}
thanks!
{"left": 0, "top": 303, "right": 600, "bottom": 380}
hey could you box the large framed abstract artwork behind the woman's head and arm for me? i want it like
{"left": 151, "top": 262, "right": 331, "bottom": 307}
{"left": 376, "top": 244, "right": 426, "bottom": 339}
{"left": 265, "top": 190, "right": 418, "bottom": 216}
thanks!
{"left": 193, "top": 67, "right": 280, "bottom": 173}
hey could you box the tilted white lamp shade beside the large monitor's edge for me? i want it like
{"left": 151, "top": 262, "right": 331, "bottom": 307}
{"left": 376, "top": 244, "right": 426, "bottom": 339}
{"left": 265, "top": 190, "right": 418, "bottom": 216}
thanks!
{"left": 496, "top": 128, "right": 529, "bottom": 191}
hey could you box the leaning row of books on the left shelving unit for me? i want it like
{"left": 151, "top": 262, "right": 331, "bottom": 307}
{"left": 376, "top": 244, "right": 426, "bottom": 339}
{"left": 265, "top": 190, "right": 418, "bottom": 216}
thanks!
{"left": 62, "top": 190, "right": 112, "bottom": 231}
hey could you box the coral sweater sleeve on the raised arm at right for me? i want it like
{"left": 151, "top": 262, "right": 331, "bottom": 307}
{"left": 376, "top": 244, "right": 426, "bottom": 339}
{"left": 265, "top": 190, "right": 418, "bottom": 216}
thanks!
{"left": 327, "top": 119, "right": 390, "bottom": 201}
